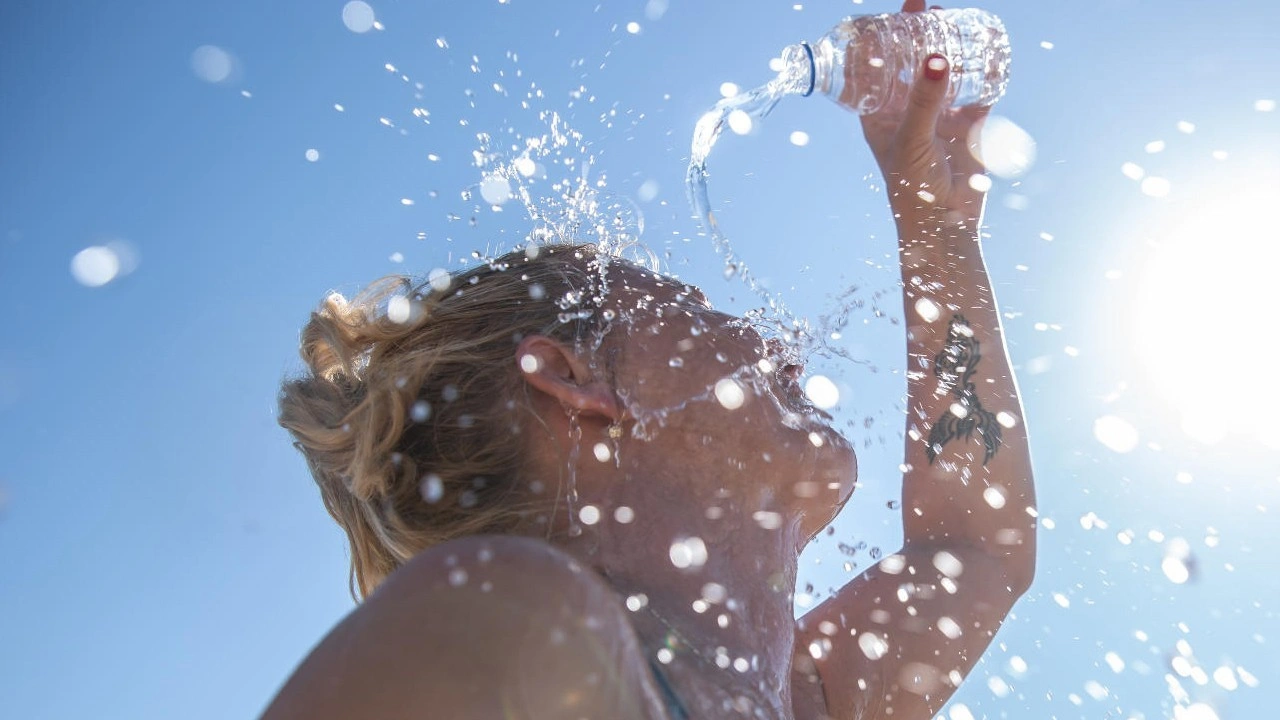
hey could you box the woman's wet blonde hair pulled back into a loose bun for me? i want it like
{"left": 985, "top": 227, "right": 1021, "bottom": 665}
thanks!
{"left": 279, "top": 245, "right": 614, "bottom": 602}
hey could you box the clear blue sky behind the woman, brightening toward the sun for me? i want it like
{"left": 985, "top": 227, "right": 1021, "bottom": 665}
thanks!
{"left": 0, "top": 0, "right": 1280, "bottom": 719}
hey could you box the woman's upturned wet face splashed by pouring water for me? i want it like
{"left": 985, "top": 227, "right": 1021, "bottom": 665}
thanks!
{"left": 604, "top": 268, "right": 858, "bottom": 541}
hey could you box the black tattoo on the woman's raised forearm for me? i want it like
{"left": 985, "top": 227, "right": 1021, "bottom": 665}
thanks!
{"left": 927, "top": 315, "right": 1000, "bottom": 465}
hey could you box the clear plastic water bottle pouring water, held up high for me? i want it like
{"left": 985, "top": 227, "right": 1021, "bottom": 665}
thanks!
{"left": 780, "top": 9, "right": 1011, "bottom": 115}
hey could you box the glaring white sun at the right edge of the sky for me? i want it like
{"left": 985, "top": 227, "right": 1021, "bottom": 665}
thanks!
{"left": 1130, "top": 172, "right": 1280, "bottom": 448}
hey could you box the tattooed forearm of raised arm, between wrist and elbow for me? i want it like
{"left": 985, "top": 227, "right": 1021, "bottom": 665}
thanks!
{"left": 899, "top": 214, "right": 1036, "bottom": 584}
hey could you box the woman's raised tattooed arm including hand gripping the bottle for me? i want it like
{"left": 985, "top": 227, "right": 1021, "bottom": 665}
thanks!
{"left": 795, "top": 7, "right": 1036, "bottom": 720}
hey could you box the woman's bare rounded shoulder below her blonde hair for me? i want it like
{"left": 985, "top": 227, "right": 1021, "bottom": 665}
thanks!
{"left": 264, "top": 536, "right": 652, "bottom": 720}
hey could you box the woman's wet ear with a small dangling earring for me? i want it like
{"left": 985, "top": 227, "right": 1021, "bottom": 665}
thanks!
{"left": 516, "top": 334, "right": 622, "bottom": 423}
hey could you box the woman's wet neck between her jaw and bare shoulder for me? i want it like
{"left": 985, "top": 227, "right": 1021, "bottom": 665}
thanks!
{"left": 557, "top": 466, "right": 801, "bottom": 705}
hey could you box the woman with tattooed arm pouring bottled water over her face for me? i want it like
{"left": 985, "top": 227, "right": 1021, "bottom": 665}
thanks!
{"left": 264, "top": 1, "right": 1036, "bottom": 720}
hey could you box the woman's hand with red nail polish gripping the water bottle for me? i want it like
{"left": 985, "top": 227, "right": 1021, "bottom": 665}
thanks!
{"left": 863, "top": 0, "right": 991, "bottom": 228}
